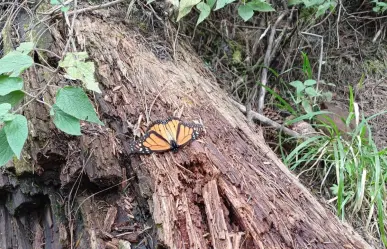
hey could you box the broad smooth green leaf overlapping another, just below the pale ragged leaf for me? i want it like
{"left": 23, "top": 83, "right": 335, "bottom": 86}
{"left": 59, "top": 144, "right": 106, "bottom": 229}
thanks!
{"left": 56, "top": 86, "right": 103, "bottom": 125}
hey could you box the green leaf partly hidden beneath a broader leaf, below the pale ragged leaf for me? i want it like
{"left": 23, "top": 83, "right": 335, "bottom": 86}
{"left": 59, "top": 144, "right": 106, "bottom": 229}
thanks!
{"left": 50, "top": 104, "right": 82, "bottom": 136}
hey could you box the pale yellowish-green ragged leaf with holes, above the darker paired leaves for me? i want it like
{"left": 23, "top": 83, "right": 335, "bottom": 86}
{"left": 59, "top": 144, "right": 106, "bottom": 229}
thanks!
{"left": 59, "top": 52, "right": 101, "bottom": 93}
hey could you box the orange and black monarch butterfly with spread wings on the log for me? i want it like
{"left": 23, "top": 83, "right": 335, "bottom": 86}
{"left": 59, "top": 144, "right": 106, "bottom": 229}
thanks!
{"left": 130, "top": 117, "right": 203, "bottom": 154}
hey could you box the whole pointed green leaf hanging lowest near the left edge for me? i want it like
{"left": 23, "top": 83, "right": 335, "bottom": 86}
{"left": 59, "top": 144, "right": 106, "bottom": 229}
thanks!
{"left": 4, "top": 115, "right": 28, "bottom": 159}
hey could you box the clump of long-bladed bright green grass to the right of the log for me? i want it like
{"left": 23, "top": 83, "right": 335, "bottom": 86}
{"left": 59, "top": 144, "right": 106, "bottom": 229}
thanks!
{"left": 282, "top": 88, "right": 387, "bottom": 245}
